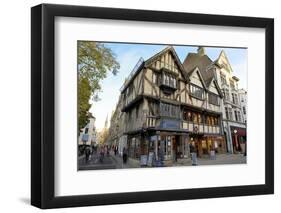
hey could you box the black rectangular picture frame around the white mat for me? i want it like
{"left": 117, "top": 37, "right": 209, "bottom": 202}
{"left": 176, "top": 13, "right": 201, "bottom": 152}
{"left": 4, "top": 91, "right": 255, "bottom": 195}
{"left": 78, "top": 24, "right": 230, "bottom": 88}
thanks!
{"left": 31, "top": 4, "right": 274, "bottom": 209}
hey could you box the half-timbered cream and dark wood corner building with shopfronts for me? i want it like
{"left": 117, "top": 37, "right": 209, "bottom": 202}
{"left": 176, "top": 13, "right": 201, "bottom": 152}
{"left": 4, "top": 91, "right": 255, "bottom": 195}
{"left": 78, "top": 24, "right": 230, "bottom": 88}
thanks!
{"left": 109, "top": 46, "right": 225, "bottom": 163}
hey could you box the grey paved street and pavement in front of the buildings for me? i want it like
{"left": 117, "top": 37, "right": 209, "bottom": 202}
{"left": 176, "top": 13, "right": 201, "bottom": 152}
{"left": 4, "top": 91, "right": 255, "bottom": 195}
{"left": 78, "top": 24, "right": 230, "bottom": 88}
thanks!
{"left": 79, "top": 152, "right": 246, "bottom": 170}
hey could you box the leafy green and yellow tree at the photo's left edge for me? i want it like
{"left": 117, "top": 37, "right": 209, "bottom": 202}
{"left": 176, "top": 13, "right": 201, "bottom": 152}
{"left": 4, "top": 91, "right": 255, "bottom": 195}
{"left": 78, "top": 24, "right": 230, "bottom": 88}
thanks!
{"left": 78, "top": 41, "right": 120, "bottom": 129}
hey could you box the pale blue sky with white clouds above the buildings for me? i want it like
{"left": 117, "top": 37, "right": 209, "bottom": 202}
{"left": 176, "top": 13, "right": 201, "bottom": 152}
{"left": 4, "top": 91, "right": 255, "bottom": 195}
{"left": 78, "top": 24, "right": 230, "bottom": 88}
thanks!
{"left": 90, "top": 43, "right": 247, "bottom": 131}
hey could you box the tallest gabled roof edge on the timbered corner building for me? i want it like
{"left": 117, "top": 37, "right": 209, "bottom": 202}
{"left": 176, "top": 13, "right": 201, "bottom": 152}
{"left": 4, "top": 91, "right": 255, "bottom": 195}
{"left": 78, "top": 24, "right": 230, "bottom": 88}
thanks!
{"left": 144, "top": 46, "right": 185, "bottom": 78}
